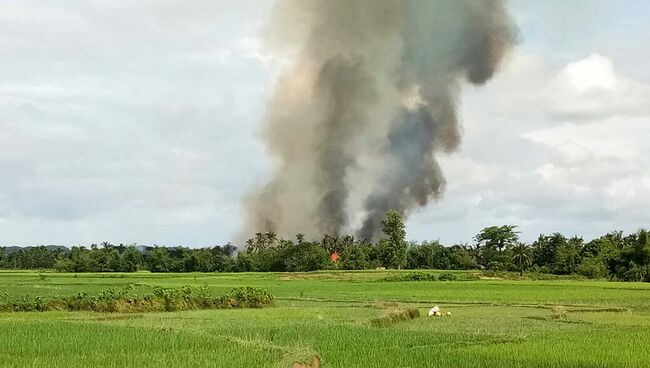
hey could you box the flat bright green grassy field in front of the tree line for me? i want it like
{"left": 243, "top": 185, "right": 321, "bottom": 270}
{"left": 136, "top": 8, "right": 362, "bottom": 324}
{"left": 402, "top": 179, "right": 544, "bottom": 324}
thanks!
{"left": 0, "top": 271, "right": 650, "bottom": 368}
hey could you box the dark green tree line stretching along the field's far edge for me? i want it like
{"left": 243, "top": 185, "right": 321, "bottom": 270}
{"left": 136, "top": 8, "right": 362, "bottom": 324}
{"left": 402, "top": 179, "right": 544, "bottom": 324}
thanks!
{"left": 0, "top": 211, "right": 650, "bottom": 282}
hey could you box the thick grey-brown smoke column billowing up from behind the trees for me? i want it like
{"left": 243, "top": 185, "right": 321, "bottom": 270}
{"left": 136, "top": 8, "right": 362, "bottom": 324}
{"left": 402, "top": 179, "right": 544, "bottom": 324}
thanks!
{"left": 244, "top": 0, "right": 515, "bottom": 239}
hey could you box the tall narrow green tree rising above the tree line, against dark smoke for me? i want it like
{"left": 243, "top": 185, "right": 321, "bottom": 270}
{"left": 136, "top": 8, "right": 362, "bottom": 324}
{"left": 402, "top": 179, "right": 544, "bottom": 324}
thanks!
{"left": 379, "top": 210, "right": 407, "bottom": 269}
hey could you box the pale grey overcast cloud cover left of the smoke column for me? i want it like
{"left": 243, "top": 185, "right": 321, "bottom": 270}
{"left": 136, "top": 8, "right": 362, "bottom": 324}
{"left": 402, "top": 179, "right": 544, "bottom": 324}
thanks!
{"left": 0, "top": 0, "right": 270, "bottom": 245}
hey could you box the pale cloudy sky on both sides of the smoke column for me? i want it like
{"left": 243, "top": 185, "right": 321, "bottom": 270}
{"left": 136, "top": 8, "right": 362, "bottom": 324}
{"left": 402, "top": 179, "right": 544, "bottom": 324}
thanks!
{"left": 0, "top": 0, "right": 650, "bottom": 247}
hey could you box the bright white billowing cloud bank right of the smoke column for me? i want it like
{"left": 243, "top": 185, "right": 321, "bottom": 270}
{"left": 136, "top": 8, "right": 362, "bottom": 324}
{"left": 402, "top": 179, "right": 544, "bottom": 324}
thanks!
{"left": 409, "top": 49, "right": 650, "bottom": 242}
